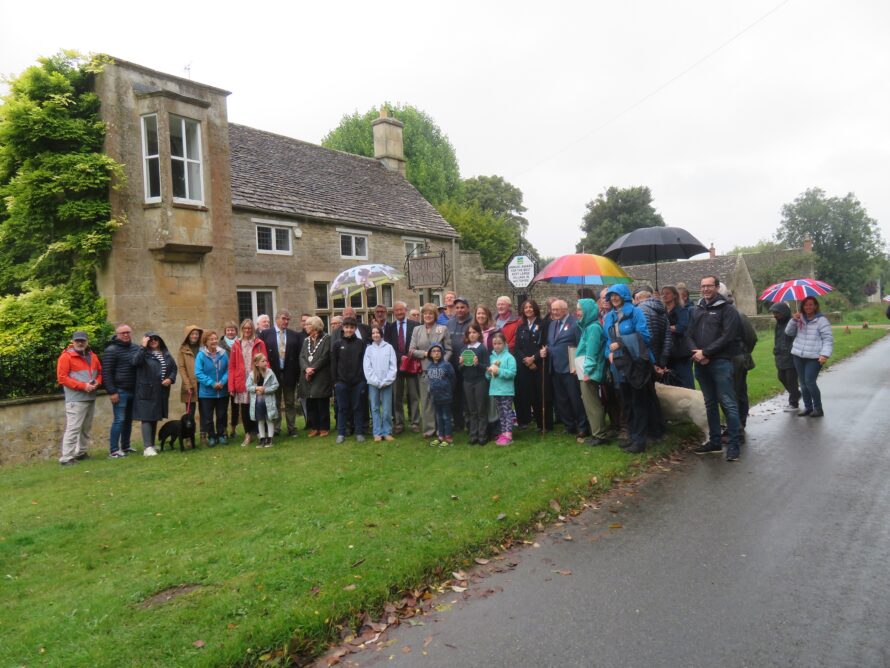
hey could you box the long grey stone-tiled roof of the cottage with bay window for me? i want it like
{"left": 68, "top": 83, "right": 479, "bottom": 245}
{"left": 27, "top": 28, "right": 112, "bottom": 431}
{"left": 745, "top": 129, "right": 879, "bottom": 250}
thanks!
{"left": 229, "top": 123, "right": 459, "bottom": 238}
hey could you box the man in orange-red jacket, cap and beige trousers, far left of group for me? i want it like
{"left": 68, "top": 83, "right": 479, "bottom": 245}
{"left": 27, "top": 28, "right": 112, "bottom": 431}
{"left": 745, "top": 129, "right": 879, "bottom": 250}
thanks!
{"left": 56, "top": 332, "right": 102, "bottom": 466}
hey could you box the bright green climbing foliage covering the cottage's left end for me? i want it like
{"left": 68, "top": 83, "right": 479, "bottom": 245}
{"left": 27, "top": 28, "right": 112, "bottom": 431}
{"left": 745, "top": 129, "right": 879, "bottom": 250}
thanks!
{"left": 0, "top": 51, "right": 124, "bottom": 399}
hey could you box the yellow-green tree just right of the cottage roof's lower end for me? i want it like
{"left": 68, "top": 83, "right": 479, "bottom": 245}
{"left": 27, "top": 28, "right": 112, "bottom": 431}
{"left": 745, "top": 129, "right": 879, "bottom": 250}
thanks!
{"left": 437, "top": 200, "right": 520, "bottom": 269}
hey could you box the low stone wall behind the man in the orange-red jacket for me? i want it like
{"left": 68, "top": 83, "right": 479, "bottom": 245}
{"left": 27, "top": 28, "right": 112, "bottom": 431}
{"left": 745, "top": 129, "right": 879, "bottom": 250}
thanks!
{"left": 0, "top": 393, "right": 114, "bottom": 466}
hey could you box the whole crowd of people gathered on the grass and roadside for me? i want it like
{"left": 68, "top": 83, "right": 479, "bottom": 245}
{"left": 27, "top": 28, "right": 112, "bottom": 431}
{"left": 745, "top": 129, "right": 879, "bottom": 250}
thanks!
{"left": 58, "top": 276, "right": 831, "bottom": 464}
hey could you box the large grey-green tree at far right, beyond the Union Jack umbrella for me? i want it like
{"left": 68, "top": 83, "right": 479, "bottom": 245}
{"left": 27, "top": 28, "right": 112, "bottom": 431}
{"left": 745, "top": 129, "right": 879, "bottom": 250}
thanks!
{"left": 776, "top": 188, "right": 884, "bottom": 302}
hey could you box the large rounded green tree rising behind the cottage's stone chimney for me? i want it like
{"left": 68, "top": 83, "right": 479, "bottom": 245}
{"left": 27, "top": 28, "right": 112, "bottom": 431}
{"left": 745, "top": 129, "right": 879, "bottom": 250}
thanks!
{"left": 321, "top": 104, "right": 460, "bottom": 206}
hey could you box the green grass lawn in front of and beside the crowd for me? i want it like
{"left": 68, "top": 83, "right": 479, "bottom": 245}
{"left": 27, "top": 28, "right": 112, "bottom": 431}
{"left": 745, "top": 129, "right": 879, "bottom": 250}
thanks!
{"left": 0, "top": 330, "right": 883, "bottom": 666}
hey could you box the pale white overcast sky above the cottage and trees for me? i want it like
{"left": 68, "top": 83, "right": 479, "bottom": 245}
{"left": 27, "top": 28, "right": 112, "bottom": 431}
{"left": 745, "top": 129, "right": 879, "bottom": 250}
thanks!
{"left": 0, "top": 0, "right": 890, "bottom": 255}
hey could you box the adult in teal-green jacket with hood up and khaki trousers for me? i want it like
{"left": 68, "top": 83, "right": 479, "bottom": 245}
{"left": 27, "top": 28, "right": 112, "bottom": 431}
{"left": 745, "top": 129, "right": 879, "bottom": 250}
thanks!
{"left": 575, "top": 299, "right": 608, "bottom": 445}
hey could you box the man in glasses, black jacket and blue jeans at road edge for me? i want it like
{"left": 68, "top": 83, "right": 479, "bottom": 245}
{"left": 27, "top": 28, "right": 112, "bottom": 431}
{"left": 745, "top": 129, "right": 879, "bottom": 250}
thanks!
{"left": 686, "top": 276, "right": 740, "bottom": 462}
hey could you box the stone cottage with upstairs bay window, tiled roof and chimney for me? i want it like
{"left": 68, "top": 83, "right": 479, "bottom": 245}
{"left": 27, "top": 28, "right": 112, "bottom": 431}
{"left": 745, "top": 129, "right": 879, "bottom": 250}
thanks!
{"left": 96, "top": 60, "right": 460, "bottom": 346}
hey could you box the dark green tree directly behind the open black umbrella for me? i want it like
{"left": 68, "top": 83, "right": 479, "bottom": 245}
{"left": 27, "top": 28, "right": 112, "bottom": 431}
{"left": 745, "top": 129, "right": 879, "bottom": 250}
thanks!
{"left": 576, "top": 186, "right": 664, "bottom": 255}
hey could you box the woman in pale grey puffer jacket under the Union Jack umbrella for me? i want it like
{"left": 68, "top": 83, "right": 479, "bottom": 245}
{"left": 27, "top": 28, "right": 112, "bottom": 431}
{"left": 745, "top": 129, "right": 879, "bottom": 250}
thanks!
{"left": 785, "top": 297, "right": 834, "bottom": 417}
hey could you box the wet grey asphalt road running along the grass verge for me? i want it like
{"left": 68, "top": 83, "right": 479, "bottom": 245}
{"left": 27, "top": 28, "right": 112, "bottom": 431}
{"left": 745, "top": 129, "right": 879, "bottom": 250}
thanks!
{"left": 345, "top": 337, "right": 890, "bottom": 668}
